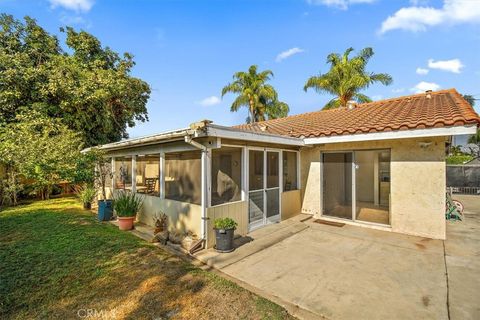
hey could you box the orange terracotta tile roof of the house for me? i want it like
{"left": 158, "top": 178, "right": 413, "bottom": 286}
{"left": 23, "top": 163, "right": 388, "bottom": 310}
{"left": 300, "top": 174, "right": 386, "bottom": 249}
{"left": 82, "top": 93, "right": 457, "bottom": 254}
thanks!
{"left": 235, "top": 89, "right": 480, "bottom": 137}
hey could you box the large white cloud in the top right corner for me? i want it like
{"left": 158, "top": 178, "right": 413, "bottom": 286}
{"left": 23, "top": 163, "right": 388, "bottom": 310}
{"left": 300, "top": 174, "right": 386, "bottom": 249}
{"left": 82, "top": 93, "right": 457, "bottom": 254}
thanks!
{"left": 380, "top": 0, "right": 480, "bottom": 33}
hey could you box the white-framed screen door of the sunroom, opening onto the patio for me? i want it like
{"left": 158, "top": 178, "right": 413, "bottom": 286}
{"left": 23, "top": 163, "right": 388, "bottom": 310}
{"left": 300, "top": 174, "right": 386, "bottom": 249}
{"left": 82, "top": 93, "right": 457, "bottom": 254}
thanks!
{"left": 248, "top": 150, "right": 280, "bottom": 230}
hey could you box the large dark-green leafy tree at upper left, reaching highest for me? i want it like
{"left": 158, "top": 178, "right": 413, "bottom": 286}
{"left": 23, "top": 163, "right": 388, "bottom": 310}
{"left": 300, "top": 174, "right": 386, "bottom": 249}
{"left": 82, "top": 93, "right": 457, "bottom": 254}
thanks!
{"left": 0, "top": 14, "right": 150, "bottom": 146}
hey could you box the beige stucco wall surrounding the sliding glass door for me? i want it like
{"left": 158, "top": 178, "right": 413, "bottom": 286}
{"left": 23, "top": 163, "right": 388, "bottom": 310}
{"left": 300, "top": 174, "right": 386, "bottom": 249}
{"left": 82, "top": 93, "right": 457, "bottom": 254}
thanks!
{"left": 301, "top": 137, "right": 446, "bottom": 239}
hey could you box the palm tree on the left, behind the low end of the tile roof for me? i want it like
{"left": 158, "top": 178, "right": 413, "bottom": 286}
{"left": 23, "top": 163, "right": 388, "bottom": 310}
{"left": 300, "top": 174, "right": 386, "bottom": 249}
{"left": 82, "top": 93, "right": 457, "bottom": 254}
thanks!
{"left": 222, "top": 65, "right": 289, "bottom": 123}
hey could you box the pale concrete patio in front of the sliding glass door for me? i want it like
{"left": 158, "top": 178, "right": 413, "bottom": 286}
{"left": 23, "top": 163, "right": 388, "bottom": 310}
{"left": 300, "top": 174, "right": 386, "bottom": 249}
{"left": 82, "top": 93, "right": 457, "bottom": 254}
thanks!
{"left": 196, "top": 197, "right": 480, "bottom": 319}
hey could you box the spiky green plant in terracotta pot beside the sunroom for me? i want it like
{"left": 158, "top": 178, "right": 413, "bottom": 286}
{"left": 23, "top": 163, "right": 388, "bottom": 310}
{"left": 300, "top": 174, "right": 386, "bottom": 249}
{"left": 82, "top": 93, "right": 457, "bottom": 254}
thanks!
{"left": 113, "top": 190, "right": 144, "bottom": 230}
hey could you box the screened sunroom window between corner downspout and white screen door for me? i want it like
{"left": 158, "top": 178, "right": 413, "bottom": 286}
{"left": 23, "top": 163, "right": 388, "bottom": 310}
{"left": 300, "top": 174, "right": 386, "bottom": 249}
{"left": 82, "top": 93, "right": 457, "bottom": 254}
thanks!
{"left": 212, "top": 147, "right": 242, "bottom": 206}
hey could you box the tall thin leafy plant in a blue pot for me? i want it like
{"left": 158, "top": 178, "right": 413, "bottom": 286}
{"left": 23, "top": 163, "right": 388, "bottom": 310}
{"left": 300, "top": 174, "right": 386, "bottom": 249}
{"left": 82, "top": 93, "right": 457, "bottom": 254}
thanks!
{"left": 94, "top": 149, "right": 113, "bottom": 221}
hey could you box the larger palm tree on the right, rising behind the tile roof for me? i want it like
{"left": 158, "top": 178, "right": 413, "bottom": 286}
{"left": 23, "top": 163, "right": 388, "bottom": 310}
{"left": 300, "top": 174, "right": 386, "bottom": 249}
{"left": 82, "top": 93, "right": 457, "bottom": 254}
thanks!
{"left": 303, "top": 48, "right": 392, "bottom": 109}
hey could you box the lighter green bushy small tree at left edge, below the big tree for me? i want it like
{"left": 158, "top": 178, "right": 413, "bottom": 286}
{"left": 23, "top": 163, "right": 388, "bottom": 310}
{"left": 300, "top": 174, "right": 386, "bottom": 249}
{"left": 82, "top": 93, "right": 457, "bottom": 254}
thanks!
{"left": 0, "top": 111, "right": 83, "bottom": 202}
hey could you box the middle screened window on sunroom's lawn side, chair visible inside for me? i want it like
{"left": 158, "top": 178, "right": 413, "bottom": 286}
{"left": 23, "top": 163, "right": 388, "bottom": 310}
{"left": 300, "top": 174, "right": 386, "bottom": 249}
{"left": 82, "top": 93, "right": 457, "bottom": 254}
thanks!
{"left": 135, "top": 154, "right": 160, "bottom": 197}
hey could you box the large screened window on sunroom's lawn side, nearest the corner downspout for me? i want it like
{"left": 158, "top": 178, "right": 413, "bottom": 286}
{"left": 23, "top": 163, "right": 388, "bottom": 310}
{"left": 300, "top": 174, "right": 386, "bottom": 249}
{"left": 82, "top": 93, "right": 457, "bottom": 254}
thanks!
{"left": 165, "top": 151, "right": 202, "bottom": 204}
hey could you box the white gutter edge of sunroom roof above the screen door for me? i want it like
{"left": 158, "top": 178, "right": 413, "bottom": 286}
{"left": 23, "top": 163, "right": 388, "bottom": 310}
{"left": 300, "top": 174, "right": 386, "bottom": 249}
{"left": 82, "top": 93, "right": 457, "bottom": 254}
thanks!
{"left": 202, "top": 124, "right": 304, "bottom": 147}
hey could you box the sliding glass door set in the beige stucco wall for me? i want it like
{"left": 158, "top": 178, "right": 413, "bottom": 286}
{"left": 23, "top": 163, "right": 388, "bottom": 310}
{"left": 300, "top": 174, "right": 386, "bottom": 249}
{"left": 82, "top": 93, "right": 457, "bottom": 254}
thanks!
{"left": 322, "top": 150, "right": 390, "bottom": 225}
